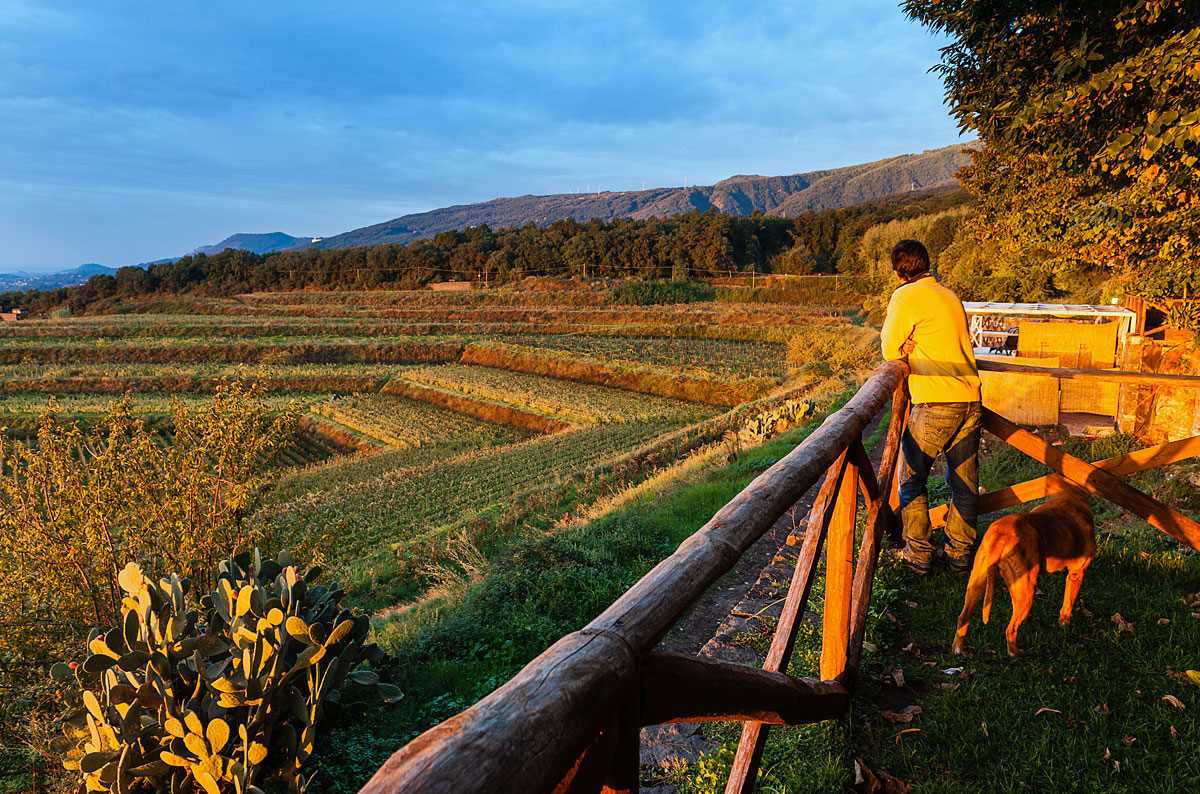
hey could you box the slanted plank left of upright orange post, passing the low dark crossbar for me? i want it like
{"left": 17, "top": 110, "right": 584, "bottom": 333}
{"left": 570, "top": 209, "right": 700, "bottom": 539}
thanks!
{"left": 725, "top": 450, "right": 848, "bottom": 794}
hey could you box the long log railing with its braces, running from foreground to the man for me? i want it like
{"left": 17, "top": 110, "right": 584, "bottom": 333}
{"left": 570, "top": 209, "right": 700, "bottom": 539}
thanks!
{"left": 362, "top": 361, "right": 907, "bottom": 794}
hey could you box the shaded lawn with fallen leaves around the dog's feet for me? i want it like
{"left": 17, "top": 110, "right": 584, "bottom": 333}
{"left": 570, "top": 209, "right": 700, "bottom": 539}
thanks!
{"left": 668, "top": 437, "right": 1200, "bottom": 794}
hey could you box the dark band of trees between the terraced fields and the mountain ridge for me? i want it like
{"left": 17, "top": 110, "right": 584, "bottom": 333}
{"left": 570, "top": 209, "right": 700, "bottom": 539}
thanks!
{"left": 0, "top": 191, "right": 970, "bottom": 314}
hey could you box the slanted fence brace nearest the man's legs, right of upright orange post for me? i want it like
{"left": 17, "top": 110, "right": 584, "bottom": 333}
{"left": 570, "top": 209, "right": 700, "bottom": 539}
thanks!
{"left": 845, "top": 390, "right": 908, "bottom": 680}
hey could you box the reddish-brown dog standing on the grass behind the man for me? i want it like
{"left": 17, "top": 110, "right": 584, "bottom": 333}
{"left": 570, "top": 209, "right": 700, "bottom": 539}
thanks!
{"left": 952, "top": 488, "right": 1096, "bottom": 656}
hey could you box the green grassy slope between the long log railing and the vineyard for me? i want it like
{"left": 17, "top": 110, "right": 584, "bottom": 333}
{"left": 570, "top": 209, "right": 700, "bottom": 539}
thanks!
{"left": 313, "top": 422, "right": 835, "bottom": 793}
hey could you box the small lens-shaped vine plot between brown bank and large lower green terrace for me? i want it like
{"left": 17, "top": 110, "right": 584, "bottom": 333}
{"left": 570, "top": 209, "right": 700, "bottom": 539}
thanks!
{"left": 312, "top": 395, "right": 532, "bottom": 447}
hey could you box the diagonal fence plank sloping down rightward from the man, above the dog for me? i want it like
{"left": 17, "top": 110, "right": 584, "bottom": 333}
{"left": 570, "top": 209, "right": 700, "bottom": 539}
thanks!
{"left": 983, "top": 408, "right": 1200, "bottom": 551}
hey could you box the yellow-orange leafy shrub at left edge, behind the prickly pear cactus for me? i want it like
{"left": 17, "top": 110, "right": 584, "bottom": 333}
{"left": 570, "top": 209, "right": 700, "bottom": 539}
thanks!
{"left": 0, "top": 380, "right": 295, "bottom": 661}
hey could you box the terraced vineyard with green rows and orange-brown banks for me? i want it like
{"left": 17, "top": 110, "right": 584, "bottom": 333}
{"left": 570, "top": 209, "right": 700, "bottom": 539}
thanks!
{"left": 0, "top": 283, "right": 848, "bottom": 607}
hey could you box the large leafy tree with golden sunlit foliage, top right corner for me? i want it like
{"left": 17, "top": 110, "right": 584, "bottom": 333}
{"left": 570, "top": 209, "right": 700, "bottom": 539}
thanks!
{"left": 904, "top": 0, "right": 1200, "bottom": 321}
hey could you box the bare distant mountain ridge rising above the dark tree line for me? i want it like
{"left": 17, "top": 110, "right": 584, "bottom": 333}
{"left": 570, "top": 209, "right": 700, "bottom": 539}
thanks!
{"left": 302, "top": 144, "right": 971, "bottom": 248}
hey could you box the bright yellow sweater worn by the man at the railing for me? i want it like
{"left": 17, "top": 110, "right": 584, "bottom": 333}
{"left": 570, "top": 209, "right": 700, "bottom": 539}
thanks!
{"left": 880, "top": 276, "right": 979, "bottom": 403}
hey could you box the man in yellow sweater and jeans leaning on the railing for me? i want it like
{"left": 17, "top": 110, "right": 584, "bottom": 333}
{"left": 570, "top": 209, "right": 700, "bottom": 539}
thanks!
{"left": 881, "top": 240, "right": 980, "bottom": 575}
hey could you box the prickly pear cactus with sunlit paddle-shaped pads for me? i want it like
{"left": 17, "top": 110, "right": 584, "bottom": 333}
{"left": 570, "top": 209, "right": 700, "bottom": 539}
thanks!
{"left": 50, "top": 551, "right": 401, "bottom": 794}
